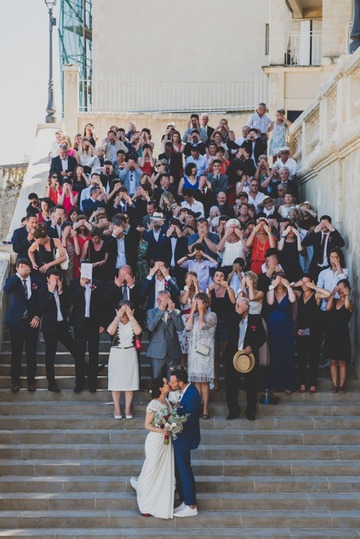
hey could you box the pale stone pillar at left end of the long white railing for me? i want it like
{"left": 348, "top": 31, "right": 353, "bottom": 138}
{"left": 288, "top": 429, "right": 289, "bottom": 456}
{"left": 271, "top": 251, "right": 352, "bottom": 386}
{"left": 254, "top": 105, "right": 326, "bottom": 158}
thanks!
{"left": 63, "top": 64, "right": 79, "bottom": 138}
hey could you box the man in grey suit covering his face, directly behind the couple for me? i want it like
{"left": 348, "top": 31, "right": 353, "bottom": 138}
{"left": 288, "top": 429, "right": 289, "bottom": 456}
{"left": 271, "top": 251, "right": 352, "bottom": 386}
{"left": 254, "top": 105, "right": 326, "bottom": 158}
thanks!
{"left": 146, "top": 290, "right": 184, "bottom": 378}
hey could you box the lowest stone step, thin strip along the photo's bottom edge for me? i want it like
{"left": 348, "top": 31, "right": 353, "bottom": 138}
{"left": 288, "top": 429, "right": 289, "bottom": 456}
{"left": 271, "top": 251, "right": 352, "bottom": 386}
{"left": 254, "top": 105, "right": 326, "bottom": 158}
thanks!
{"left": 0, "top": 527, "right": 360, "bottom": 539}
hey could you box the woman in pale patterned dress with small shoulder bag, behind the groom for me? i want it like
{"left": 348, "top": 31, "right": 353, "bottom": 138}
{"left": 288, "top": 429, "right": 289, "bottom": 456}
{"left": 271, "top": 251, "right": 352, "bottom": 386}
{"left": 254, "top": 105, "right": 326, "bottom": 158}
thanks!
{"left": 186, "top": 292, "right": 217, "bottom": 419}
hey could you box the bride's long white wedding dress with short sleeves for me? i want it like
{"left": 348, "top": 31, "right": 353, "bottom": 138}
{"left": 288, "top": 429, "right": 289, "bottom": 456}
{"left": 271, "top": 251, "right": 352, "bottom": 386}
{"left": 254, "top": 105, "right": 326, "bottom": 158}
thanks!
{"left": 133, "top": 399, "right": 175, "bottom": 518}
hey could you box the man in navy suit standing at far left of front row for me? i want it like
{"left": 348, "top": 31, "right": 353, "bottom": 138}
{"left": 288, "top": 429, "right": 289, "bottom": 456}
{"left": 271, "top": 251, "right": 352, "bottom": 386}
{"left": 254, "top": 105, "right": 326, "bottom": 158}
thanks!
{"left": 4, "top": 258, "right": 40, "bottom": 393}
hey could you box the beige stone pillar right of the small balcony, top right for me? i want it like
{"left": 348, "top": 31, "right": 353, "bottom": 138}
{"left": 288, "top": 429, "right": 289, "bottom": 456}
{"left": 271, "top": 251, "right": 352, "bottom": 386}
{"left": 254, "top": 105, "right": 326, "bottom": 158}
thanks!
{"left": 322, "top": 0, "right": 353, "bottom": 65}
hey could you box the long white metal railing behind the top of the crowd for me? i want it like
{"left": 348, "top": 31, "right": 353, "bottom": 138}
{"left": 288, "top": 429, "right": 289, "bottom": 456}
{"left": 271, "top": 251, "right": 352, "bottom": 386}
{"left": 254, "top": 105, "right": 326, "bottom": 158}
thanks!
{"left": 80, "top": 75, "right": 269, "bottom": 113}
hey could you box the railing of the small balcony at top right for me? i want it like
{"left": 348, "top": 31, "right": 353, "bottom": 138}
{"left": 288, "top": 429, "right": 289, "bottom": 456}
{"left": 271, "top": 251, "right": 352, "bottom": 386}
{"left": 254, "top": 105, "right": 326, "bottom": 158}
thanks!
{"left": 284, "top": 31, "right": 322, "bottom": 66}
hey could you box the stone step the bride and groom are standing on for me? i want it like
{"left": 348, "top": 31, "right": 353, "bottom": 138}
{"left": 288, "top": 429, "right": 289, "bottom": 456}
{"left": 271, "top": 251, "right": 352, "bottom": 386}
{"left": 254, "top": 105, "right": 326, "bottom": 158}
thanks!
{"left": 0, "top": 510, "right": 360, "bottom": 535}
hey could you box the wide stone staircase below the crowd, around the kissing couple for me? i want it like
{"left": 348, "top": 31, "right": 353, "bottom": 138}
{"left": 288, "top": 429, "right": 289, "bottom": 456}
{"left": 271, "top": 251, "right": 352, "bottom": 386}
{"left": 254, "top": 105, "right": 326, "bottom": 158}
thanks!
{"left": 0, "top": 337, "right": 360, "bottom": 539}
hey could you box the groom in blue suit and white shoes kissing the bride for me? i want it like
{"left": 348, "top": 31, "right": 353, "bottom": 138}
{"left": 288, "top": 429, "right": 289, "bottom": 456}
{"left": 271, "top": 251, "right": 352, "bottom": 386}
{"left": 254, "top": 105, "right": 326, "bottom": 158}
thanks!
{"left": 170, "top": 369, "right": 201, "bottom": 517}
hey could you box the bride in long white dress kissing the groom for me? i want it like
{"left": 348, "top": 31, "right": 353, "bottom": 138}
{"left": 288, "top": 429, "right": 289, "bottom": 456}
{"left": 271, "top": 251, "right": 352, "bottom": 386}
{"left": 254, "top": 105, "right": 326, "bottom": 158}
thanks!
{"left": 130, "top": 378, "right": 175, "bottom": 518}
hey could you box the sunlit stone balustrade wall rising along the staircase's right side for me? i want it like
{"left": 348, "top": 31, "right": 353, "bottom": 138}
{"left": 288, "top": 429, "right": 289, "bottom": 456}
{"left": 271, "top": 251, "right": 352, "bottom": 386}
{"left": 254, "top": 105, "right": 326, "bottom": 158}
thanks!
{"left": 290, "top": 49, "right": 360, "bottom": 373}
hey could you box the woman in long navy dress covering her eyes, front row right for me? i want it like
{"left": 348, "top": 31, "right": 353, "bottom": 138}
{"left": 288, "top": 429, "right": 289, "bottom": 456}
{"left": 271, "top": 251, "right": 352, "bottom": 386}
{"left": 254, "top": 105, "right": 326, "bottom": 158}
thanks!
{"left": 267, "top": 272, "right": 296, "bottom": 395}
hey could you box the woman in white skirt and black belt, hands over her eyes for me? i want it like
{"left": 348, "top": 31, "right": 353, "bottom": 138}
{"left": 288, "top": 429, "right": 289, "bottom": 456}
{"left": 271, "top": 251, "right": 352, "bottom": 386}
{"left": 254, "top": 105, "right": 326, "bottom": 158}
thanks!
{"left": 107, "top": 300, "right": 142, "bottom": 419}
